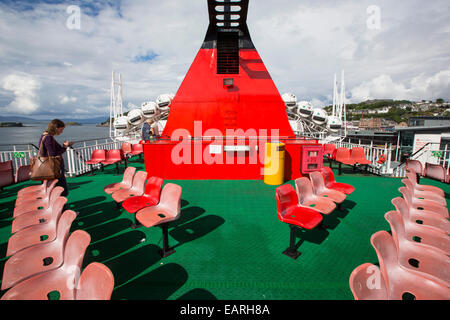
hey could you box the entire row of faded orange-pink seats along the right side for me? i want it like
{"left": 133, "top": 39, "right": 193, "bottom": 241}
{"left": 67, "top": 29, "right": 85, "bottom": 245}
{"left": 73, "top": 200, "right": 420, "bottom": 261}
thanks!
{"left": 349, "top": 169, "right": 450, "bottom": 300}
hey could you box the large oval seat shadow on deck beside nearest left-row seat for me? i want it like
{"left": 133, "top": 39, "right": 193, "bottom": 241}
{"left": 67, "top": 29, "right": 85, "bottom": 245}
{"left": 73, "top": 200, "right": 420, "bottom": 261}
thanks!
{"left": 112, "top": 263, "right": 188, "bottom": 300}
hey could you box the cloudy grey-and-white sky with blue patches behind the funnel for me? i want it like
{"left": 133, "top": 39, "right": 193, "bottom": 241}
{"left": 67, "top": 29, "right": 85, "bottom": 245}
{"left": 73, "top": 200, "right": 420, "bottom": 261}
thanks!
{"left": 0, "top": 0, "right": 450, "bottom": 118}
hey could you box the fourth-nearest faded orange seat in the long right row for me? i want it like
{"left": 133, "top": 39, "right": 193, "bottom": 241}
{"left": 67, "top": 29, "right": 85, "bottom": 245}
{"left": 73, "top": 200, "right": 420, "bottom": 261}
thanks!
{"left": 392, "top": 194, "right": 450, "bottom": 234}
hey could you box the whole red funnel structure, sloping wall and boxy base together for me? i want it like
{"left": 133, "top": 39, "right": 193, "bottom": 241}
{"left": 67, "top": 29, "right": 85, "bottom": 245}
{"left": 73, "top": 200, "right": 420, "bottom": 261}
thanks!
{"left": 144, "top": 49, "right": 317, "bottom": 180}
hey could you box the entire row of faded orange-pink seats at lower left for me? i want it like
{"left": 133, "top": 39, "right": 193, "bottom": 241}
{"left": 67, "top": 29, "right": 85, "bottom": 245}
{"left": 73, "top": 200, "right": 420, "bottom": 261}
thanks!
{"left": 1, "top": 180, "right": 114, "bottom": 300}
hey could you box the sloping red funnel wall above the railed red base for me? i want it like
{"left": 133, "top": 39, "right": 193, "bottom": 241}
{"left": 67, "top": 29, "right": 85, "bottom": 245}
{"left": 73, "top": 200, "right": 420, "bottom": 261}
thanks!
{"left": 162, "top": 49, "right": 294, "bottom": 137}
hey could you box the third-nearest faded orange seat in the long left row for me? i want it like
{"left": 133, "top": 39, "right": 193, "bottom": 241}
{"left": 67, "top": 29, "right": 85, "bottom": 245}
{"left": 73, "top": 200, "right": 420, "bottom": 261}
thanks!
{"left": 6, "top": 202, "right": 75, "bottom": 257}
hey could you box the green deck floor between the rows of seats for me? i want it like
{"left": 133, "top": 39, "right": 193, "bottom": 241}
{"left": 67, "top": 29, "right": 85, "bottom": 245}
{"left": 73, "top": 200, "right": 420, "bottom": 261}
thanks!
{"left": 0, "top": 160, "right": 450, "bottom": 300}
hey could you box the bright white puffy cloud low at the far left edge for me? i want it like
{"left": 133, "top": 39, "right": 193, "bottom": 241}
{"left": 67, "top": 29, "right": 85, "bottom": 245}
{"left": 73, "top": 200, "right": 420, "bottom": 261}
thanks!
{"left": 2, "top": 73, "right": 41, "bottom": 114}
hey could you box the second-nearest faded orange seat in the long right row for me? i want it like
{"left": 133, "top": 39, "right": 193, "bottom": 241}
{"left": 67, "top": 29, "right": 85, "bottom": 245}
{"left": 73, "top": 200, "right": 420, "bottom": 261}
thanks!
{"left": 370, "top": 231, "right": 450, "bottom": 300}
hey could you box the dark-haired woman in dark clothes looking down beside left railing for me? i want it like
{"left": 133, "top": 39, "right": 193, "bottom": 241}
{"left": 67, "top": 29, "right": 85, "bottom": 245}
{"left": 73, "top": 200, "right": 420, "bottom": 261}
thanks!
{"left": 39, "top": 119, "right": 73, "bottom": 197}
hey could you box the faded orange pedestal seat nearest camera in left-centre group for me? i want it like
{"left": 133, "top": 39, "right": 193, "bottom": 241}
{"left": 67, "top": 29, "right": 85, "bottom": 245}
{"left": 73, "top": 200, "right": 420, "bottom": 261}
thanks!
{"left": 136, "top": 183, "right": 182, "bottom": 258}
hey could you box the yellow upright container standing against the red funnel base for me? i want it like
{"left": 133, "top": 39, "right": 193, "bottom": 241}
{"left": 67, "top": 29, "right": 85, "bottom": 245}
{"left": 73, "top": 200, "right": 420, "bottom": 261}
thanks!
{"left": 264, "top": 142, "right": 285, "bottom": 186}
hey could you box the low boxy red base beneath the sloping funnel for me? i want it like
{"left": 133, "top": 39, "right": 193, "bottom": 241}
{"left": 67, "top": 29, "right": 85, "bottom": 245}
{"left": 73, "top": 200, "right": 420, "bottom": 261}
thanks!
{"left": 144, "top": 139, "right": 315, "bottom": 180}
